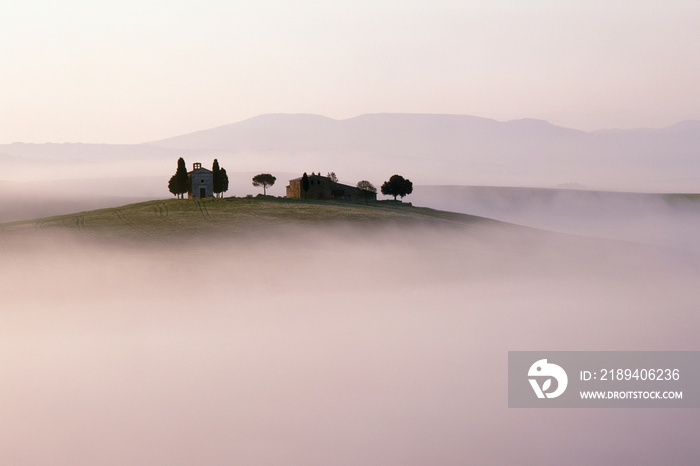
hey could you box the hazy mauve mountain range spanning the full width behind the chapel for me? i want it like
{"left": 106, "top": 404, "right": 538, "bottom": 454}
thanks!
{"left": 0, "top": 113, "right": 700, "bottom": 192}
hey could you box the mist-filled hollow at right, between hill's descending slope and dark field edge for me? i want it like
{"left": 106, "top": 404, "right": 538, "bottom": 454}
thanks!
{"left": 410, "top": 186, "right": 700, "bottom": 252}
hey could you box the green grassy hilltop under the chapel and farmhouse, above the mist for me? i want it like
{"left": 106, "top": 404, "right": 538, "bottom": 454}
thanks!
{"left": 0, "top": 197, "right": 498, "bottom": 242}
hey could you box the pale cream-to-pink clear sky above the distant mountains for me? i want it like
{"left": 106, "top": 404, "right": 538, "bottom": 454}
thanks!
{"left": 0, "top": 0, "right": 700, "bottom": 143}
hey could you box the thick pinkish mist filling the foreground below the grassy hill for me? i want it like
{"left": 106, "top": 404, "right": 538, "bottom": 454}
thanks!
{"left": 0, "top": 223, "right": 700, "bottom": 466}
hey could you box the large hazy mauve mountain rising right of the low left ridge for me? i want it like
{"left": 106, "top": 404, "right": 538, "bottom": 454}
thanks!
{"left": 150, "top": 113, "right": 700, "bottom": 191}
